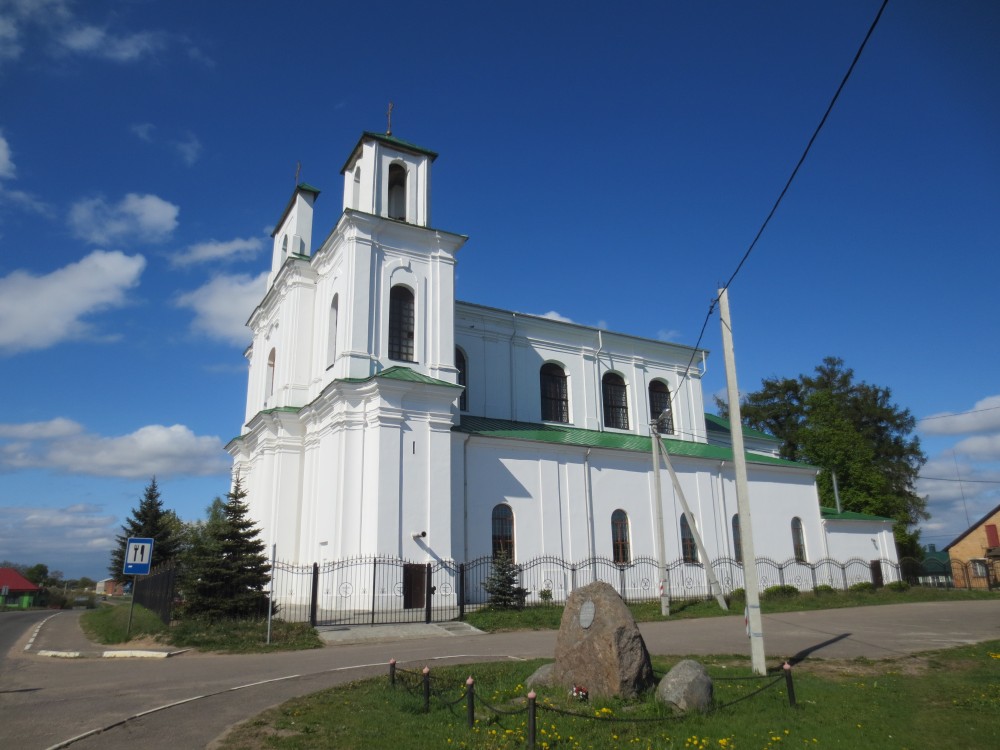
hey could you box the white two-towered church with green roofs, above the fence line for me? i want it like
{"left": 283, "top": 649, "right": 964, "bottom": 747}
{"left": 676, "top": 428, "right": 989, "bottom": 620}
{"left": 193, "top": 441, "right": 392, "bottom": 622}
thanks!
{"left": 227, "top": 132, "right": 897, "bottom": 604}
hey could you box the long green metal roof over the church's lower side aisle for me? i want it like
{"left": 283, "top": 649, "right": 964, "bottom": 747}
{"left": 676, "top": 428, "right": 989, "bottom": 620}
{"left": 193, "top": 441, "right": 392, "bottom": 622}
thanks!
{"left": 454, "top": 415, "right": 812, "bottom": 468}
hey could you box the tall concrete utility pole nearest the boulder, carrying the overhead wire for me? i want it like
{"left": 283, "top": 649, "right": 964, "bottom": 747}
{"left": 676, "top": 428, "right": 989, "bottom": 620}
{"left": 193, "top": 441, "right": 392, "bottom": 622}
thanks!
{"left": 719, "top": 289, "right": 767, "bottom": 675}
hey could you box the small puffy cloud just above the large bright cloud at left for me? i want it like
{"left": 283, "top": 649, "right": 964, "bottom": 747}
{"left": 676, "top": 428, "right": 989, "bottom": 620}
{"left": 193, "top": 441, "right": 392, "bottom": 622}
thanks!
{"left": 69, "top": 193, "right": 180, "bottom": 245}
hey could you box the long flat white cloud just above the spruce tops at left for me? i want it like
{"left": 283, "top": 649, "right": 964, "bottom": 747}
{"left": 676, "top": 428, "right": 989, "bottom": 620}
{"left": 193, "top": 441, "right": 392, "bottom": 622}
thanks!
{"left": 0, "top": 418, "right": 229, "bottom": 478}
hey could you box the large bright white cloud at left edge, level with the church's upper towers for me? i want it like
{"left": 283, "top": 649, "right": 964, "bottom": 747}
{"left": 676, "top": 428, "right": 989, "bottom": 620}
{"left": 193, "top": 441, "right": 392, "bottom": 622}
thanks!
{"left": 0, "top": 251, "right": 146, "bottom": 352}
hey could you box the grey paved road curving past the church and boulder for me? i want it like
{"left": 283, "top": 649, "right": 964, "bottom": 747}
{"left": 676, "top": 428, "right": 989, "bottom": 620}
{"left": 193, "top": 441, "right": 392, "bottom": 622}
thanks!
{"left": 0, "top": 600, "right": 1000, "bottom": 750}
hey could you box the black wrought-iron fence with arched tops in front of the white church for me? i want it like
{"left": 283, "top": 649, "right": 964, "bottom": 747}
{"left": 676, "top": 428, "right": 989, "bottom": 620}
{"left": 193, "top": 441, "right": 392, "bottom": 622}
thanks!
{"left": 262, "top": 556, "right": 932, "bottom": 626}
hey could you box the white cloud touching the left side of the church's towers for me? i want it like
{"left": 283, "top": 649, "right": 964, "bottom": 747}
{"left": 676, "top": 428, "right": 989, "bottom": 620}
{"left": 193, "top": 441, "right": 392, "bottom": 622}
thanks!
{"left": 177, "top": 272, "right": 267, "bottom": 346}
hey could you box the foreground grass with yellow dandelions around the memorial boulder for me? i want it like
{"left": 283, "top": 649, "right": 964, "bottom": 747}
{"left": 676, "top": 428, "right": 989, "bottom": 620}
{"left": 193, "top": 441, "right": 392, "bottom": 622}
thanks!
{"left": 221, "top": 641, "right": 1000, "bottom": 750}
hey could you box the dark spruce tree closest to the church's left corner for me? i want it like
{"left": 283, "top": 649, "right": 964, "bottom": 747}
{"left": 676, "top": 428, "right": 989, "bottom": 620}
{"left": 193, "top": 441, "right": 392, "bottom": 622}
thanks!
{"left": 181, "top": 477, "right": 271, "bottom": 620}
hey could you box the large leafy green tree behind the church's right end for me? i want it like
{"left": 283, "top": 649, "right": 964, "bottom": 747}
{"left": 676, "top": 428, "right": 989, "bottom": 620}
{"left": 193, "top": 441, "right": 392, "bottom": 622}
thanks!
{"left": 716, "top": 357, "right": 928, "bottom": 555}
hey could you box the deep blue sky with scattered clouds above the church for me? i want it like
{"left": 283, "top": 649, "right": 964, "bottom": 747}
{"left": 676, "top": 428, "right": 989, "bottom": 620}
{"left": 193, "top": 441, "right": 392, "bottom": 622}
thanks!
{"left": 0, "top": 0, "right": 1000, "bottom": 577}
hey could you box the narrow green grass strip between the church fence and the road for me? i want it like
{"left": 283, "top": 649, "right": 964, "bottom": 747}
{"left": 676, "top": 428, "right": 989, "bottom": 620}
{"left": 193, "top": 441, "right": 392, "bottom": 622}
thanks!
{"left": 465, "top": 586, "right": 1000, "bottom": 633}
